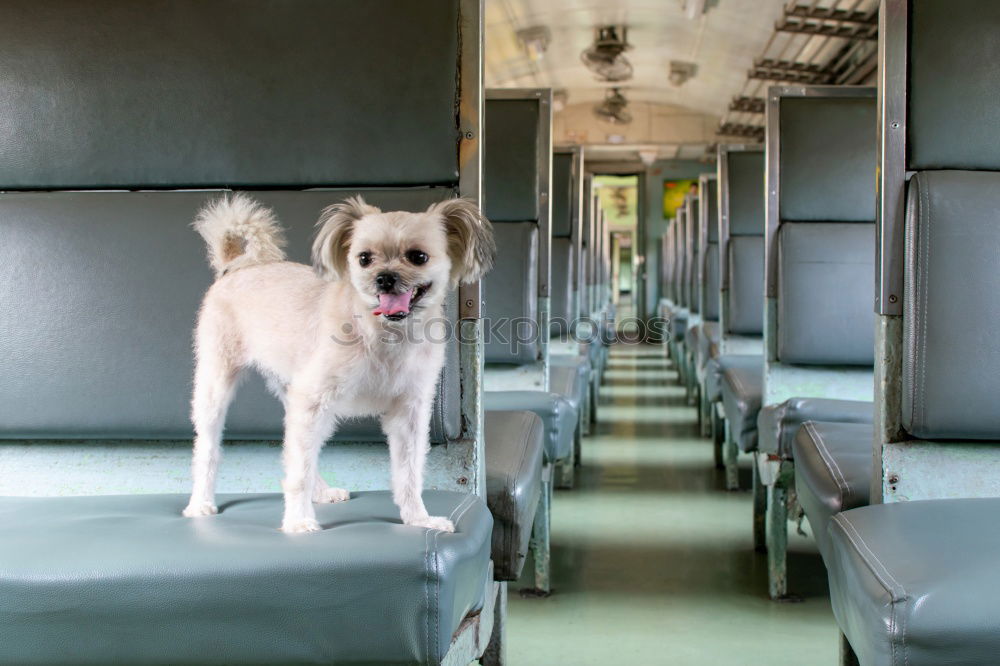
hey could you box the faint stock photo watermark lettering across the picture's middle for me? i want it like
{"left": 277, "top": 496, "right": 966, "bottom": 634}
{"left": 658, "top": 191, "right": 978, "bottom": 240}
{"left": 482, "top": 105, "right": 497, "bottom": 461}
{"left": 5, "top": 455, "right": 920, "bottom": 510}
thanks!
{"left": 331, "top": 315, "right": 670, "bottom": 356}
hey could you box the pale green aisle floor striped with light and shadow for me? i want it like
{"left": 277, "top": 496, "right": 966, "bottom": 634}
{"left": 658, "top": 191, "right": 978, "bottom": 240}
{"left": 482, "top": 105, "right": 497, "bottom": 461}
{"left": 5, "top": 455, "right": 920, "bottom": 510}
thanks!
{"left": 507, "top": 346, "right": 837, "bottom": 666}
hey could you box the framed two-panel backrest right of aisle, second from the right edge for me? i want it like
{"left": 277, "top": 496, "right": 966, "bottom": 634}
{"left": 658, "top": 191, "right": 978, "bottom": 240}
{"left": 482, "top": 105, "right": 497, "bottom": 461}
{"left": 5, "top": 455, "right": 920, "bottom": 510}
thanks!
{"left": 764, "top": 86, "right": 876, "bottom": 368}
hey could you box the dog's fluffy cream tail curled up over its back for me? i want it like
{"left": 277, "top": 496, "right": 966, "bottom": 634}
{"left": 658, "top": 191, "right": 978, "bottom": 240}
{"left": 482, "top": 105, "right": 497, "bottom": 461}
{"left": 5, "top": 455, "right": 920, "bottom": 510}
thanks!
{"left": 192, "top": 194, "right": 285, "bottom": 278}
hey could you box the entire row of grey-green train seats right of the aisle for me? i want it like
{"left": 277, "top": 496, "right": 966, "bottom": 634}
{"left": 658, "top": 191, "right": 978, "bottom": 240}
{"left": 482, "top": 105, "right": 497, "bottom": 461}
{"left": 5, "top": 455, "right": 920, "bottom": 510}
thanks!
{"left": 661, "top": 0, "right": 1000, "bottom": 665}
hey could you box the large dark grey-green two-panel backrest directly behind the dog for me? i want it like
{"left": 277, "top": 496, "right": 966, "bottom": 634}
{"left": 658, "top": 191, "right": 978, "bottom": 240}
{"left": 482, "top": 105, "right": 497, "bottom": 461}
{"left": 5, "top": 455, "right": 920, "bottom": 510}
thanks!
{"left": 0, "top": 0, "right": 482, "bottom": 491}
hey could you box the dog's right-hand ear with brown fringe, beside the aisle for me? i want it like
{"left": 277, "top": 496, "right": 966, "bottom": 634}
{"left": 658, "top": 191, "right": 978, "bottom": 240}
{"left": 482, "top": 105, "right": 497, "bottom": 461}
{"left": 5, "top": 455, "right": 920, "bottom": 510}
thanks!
{"left": 427, "top": 199, "right": 497, "bottom": 287}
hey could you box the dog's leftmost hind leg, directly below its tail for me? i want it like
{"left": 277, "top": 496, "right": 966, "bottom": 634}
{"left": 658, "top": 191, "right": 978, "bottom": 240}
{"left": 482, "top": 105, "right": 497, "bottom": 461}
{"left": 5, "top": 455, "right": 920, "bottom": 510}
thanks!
{"left": 184, "top": 322, "right": 241, "bottom": 518}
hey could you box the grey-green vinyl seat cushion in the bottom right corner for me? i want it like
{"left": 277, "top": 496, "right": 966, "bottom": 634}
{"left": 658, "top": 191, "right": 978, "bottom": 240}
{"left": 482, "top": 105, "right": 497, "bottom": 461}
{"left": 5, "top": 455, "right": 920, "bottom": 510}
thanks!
{"left": 826, "top": 498, "right": 1000, "bottom": 666}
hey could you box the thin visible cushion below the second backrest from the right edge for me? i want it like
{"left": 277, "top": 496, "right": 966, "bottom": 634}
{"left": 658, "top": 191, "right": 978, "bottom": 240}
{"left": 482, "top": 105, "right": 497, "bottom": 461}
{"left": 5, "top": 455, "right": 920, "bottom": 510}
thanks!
{"left": 757, "top": 398, "right": 875, "bottom": 459}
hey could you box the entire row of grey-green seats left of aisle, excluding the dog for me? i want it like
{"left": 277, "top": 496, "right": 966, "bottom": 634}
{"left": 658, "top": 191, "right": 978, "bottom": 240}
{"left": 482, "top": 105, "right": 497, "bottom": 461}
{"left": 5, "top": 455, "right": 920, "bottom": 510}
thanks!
{"left": 0, "top": 0, "right": 610, "bottom": 664}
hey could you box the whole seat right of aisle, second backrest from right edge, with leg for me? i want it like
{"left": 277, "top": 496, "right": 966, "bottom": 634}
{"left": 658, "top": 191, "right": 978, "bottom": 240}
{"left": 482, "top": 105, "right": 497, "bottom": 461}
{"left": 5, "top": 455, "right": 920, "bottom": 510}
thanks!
{"left": 753, "top": 86, "right": 877, "bottom": 598}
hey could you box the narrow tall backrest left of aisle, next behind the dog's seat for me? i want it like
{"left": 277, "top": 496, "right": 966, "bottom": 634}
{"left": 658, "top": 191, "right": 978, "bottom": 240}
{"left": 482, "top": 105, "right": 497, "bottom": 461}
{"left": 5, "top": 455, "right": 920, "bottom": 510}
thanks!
{"left": 483, "top": 88, "right": 552, "bottom": 371}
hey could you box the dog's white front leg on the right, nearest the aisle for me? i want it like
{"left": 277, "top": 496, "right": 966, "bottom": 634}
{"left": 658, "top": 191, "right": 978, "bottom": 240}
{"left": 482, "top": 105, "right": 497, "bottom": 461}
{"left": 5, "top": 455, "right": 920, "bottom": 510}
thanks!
{"left": 382, "top": 400, "right": 455, "bottom": 532}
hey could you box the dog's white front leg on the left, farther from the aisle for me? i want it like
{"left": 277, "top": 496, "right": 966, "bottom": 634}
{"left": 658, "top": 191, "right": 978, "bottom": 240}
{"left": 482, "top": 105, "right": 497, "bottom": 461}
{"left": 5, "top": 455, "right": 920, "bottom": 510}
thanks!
{"left": 281, "top": 390, "right": 336, "bottom": 534}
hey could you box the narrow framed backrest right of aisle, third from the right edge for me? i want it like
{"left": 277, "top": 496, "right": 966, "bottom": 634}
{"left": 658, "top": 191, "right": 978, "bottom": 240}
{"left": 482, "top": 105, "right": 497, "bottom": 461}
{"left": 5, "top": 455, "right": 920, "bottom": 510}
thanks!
{"left": 718, "top": 145, "right": 764, "bottom": 340}
